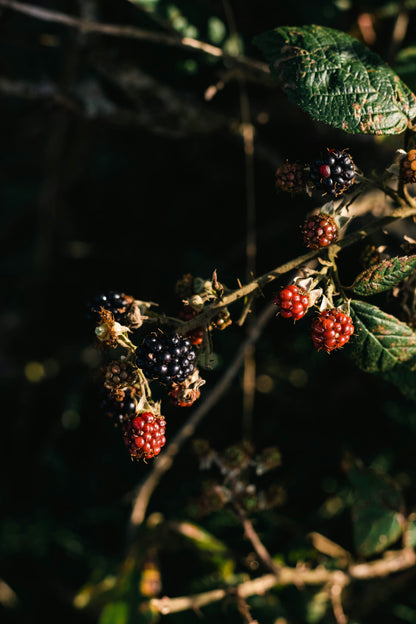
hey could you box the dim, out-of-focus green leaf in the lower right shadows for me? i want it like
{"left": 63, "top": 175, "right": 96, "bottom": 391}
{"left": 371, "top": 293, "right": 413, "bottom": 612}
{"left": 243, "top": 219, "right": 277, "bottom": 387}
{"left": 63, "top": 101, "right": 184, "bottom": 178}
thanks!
{"left": 348, "top": 461, "right": 404, "bottom": 557}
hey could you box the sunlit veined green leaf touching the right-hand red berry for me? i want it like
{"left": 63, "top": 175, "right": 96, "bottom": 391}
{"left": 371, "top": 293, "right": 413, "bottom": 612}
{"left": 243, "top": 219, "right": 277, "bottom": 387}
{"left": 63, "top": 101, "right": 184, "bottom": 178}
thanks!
{"left": 349, "top": 299, "right": 416, "bottom": 373}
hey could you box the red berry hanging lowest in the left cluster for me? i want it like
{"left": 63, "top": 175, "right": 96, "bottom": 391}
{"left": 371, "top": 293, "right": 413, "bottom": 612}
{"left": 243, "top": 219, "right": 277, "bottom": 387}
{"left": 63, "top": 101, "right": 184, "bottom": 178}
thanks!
{"left": 123, "top": 412, "right": 166, "bottom": 459}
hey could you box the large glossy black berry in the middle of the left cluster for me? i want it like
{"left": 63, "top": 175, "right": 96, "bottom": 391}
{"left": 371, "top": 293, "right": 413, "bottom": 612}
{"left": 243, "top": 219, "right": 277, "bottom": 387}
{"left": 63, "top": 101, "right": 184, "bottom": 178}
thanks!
{"left": 136, "top": 331, "right": 196, "bottom": 386}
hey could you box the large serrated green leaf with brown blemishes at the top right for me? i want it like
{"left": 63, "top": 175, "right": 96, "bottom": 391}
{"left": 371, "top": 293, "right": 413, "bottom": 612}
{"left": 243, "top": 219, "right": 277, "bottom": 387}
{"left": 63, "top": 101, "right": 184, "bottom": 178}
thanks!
{"left": 254, "top": 24, "right": 416, "bottom": 134}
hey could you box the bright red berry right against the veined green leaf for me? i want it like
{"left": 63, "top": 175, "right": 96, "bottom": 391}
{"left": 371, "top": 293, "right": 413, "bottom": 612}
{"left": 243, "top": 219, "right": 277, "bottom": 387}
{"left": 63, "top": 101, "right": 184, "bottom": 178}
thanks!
{"left": 312, "top": 308, "right": 354, "bottom": 353}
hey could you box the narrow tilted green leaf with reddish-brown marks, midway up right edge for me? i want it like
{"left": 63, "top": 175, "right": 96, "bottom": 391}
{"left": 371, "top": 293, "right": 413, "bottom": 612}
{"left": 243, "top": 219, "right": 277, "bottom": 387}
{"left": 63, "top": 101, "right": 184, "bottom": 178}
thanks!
{"left": 352, "top": 255, "right": 416, "bottom": 297}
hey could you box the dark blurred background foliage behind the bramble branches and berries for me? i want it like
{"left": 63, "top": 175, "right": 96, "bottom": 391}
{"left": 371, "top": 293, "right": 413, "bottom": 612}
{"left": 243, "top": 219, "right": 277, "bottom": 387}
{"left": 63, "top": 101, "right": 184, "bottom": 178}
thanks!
{"left": 4, "top": 0, "right": 416, "bottom": 624}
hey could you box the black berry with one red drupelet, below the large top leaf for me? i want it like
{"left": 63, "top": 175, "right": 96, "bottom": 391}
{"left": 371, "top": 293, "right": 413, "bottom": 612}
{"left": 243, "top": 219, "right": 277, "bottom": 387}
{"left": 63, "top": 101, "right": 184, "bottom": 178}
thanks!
{"left": 309, "top": 149, "right": 356, "bottom": 197}
